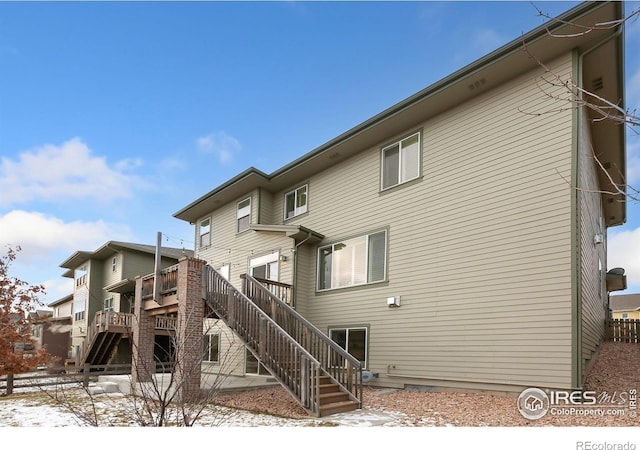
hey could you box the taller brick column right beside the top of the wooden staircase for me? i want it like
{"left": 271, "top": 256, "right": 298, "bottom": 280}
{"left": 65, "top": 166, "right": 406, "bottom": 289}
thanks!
{"left": 174, "top": 258, "right": 205, "bottom": 401}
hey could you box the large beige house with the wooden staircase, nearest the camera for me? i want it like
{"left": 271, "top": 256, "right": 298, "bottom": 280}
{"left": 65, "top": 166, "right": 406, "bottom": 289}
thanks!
{"left": 169, "top": 2, "right": 626, "bottom": 404}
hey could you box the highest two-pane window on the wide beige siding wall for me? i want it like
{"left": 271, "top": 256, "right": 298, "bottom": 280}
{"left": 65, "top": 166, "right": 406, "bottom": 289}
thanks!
{"left": 382, "top": 133, "right": 420, "bottom": 189}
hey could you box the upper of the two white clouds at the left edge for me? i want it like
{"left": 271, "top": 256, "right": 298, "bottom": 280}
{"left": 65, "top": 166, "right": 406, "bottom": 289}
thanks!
{"left": 0, "top": 138, "right": 141, "bottom": 206}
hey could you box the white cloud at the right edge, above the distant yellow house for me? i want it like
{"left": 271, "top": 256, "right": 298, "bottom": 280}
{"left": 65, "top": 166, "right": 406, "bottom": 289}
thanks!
{"left": 607, "top": 228, "right": 640, "bottom": 286}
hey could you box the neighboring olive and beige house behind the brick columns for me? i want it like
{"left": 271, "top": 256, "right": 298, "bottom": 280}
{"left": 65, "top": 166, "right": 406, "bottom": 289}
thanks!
{"left": 60, "top": 241, "right": 193, "bottom": 363}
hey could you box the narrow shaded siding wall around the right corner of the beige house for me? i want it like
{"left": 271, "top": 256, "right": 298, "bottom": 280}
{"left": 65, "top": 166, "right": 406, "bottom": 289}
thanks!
{"left": 578, "top": 107, "right": 607, "bottom": 383}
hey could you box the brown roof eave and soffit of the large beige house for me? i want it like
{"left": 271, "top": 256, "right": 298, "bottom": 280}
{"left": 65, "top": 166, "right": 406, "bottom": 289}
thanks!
{"left": 173, "top": 1, "right": 626, "bottom": 226}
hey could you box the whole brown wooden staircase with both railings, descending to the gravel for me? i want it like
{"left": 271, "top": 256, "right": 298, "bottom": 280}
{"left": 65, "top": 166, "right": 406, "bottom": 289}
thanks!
{"left": 203, "top": 266, "right": 362, "bottom": 417}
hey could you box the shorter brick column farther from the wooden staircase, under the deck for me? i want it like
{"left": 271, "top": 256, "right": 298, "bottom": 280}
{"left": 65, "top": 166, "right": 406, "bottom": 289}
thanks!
{"left": 131, "top": 277, "right": 156, "bottom": 386}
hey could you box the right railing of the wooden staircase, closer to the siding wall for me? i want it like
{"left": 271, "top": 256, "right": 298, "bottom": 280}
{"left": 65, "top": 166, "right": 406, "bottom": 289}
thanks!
{"left": 241, "top": 274, "right": 362, "bottom": 407}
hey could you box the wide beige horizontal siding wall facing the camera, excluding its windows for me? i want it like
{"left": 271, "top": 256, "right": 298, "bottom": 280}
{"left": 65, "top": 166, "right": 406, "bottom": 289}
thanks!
{"left": 296, "top": 51, "right": 572, "bottom": 387}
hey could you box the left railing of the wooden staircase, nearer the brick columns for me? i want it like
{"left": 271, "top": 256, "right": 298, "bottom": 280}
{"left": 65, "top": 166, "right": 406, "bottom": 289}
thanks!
{"left": 203, "top": 266, "right": 321, "bottom": 416}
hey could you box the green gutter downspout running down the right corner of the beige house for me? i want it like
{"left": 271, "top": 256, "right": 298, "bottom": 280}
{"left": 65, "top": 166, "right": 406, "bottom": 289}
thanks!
{"left": 572, "top": 19, "right": 624, "bottom": 390}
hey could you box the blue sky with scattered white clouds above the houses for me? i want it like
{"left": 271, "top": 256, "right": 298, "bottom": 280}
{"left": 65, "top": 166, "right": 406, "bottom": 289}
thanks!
{"left": 0, "top": 1, "right": 640, "bottom": 302}
